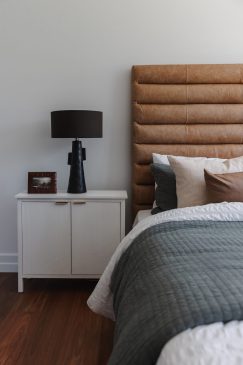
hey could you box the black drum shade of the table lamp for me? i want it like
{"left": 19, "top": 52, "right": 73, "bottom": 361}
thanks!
{"left": 51, "top": 110, "right": 102, "bottom": 138}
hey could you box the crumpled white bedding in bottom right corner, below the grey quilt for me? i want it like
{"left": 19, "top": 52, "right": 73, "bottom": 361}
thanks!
{"left": 159, "top": 321, "right": 243, "bottom": 365}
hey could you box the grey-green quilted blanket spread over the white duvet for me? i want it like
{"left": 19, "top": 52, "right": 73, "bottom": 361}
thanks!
{"left": 109, "top": 221, "right": 243, "bottom": 365}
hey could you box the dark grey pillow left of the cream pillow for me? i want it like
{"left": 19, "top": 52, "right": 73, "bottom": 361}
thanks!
{"left": 151, "top": 163, "right": 177, "bottom": 214}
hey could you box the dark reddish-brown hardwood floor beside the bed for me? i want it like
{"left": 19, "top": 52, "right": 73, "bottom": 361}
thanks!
{"left": 0, "top": 273, "right": 113, "bottom": 365}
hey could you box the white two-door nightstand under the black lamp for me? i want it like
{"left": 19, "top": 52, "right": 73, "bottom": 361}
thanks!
{"left": 16, "top": 190, "right": 127, "bottom": 292}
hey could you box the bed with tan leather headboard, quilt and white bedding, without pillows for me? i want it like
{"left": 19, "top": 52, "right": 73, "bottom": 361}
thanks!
{"left": 88, "top": 65, "right": 243, "bottom": 365}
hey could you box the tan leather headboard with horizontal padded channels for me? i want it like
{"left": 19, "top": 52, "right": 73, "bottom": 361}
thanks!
{"left": 132, "top": 65, "right": 243, "bottom": 214}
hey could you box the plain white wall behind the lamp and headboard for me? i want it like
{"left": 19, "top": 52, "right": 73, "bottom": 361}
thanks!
{"left": 0, "top": 0, "right": 243, "bottom": 270}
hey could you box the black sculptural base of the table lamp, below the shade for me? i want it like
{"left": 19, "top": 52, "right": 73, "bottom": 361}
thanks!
{"left": 67, "top": 139, "right": 87, "bottom": 194}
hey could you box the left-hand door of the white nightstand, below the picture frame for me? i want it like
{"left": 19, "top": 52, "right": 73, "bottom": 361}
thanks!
{"left": 22, "top": 201, "right": 71, "bottom": 275}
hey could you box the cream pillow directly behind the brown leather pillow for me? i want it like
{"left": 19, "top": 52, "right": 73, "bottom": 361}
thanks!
{"left": 168, "top": 156, "right": 243, "bottom": 208}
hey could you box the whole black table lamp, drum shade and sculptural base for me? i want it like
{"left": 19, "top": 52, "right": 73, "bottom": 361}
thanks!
{"left": 51, "top": 110, "right": 102, "bottom": 194}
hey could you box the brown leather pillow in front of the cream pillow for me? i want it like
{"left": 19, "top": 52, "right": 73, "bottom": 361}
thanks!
{"left": 204, "top": 170, "right": 243, "bottom": 203}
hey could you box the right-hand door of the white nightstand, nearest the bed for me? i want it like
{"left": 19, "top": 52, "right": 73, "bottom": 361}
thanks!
{"left": 72, "top": 201, "right": 121, "bottom": 277}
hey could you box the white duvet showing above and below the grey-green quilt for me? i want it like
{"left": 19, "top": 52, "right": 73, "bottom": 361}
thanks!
{"left": 88, "top": 203, "right": 243, "bottom": 365}
